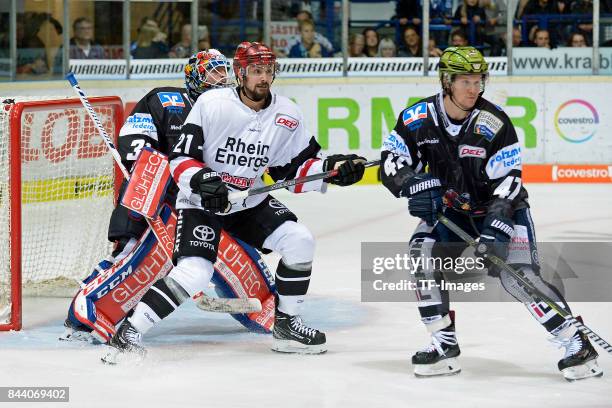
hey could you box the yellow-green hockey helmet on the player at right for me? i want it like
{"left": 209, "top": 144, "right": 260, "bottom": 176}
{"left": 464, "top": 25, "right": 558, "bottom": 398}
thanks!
{"left": 438, "top": 47, "right": 489, "bottom": 92}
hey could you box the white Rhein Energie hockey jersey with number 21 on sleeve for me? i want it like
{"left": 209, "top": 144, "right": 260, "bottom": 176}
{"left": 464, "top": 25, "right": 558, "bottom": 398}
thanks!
{"left": 170, "top": 88, "right": 327, "bottom": 213}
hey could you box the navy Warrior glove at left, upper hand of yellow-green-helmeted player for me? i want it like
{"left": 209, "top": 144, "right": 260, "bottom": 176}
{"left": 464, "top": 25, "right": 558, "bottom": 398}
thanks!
{"left": 401, "top": 173, "right": 442, "bottom": 226}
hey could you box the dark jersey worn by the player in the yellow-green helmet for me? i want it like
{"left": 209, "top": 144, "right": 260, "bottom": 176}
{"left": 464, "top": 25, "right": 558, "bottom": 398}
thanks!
{"left": 381, "top": 93, "right": 527, "bottom": 209}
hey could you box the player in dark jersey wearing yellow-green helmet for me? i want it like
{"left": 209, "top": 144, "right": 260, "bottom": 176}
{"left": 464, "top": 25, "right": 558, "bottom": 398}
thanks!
{"left": 381, "top": 47, "right": 602, "bottom": 380}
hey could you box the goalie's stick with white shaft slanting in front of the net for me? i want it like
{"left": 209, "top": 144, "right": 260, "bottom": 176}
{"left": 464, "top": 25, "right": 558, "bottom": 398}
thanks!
{"left": 66, "top": 72, "right": 261, "bottom": 313}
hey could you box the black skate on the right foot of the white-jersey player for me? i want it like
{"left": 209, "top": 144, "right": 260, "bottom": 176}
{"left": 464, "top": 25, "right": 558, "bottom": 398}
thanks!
{"left": 272, "top": 309, "right": 327, "bottom": 354}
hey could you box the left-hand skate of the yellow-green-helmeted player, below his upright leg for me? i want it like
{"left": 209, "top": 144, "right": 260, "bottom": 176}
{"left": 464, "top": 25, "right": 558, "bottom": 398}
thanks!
{"left": 412, "top": 315, "right": 461, "bottom": 377}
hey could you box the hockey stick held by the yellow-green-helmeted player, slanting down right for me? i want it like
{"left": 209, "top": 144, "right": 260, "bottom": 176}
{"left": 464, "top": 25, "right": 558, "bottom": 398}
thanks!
{"left": 438, "top": 214, "right": 612, "bottom": 354}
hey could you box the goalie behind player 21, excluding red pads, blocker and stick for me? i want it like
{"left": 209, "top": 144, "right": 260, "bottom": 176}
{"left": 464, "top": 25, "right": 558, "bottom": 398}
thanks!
{"left": 60, "top": 49, "right": 230, "bottom": 340}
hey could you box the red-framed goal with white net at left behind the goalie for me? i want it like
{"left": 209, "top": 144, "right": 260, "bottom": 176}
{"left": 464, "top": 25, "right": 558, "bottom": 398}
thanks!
{"left": 0, "top": 96, "right": 123, "bottom": 330}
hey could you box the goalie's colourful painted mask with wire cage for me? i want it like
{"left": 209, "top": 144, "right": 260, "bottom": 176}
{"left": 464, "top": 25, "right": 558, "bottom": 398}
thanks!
{"left": 185, "top": 48, "right": 231, "bottom": 101}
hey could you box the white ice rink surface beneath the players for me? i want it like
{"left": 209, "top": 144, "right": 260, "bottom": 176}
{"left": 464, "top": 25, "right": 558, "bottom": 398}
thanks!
{"left": 0, "top": 185, "right": 612, "bottom": 408}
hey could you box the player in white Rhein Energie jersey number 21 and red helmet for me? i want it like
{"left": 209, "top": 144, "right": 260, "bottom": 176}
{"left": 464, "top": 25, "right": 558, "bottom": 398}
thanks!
{"left": 103, "top": 42, "right": 366, "bottom": 360}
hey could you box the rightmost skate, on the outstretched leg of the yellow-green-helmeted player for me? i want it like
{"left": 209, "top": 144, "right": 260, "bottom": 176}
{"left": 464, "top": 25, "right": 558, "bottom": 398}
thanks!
{"left": 551, "top": 330, "right": 603, "bottom": 381}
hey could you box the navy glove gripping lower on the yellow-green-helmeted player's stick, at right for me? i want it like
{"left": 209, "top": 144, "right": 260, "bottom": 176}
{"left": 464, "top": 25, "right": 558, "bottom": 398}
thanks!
{"left": 476, "top": 214, "right": 514, "bottom": 261}
